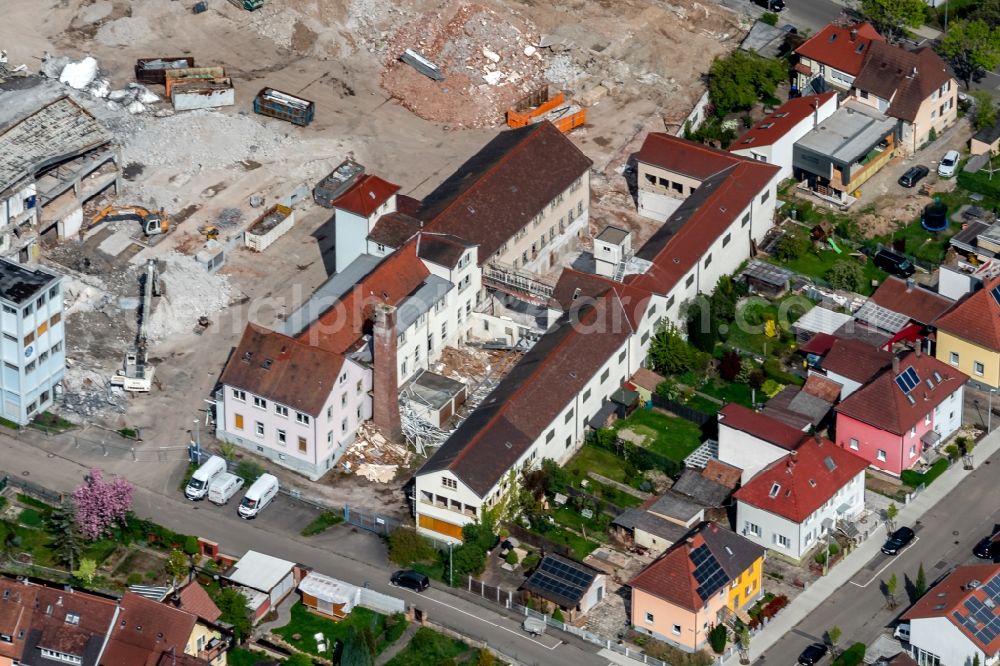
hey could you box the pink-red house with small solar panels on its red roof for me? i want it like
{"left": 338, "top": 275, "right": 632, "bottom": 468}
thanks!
{"left": 836, "top": 352, "right": 968, "bottom": 476}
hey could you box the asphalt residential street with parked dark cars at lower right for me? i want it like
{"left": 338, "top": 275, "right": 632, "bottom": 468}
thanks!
{"left": 758, "top": 440, "right": 1000, "bottom": 666}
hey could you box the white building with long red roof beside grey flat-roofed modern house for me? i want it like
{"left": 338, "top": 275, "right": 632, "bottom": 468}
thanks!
{"left": 729, "top": 91, "right": 837, "bottom": 180}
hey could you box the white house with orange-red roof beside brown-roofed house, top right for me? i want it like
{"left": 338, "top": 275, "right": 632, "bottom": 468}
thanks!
{"left": 795, "top": 23, "right": 885, "bottom": 94}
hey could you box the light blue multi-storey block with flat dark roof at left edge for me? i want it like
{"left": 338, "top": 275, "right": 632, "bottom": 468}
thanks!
{"left": 0, "top": 258, "right": 66, "bottom": 425}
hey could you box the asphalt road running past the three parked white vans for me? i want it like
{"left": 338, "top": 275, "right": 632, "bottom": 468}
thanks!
{"left": 0, "top": 434, "right": 608, "bottom": 666}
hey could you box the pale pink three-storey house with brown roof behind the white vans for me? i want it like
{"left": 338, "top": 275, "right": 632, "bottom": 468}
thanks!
{"left": 216, "top": 325, "right": 372, "bottom": 480}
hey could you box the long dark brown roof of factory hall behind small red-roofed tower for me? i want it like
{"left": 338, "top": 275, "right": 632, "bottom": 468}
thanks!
{"left": 417, "top": 121, "right": 593, "bottom": 264}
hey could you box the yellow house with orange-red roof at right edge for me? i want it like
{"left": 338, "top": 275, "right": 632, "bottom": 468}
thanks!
{"left": 934, "top": 278, "right": 1000, "bottom": 389}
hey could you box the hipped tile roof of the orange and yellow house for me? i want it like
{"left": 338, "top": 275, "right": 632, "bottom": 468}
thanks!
{"left": 628, "top": 523, "right": 764, "bottom": 612}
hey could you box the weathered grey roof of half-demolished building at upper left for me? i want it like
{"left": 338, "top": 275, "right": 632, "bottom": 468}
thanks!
{"left": 0, "top": 93, "right": 111, "bottom": 192}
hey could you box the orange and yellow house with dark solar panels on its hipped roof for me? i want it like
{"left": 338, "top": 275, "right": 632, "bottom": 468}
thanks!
{"left": 629, "top": 523, "right": 765, "bottom": 652}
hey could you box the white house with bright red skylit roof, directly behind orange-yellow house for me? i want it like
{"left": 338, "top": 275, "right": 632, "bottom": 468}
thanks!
{"left": 735, "top": 437, "right": 868, "bottom": 560}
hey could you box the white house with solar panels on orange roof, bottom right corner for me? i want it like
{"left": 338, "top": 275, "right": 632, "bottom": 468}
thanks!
{"left": 901, "top": 564, "right": 1000, "bottom": 666}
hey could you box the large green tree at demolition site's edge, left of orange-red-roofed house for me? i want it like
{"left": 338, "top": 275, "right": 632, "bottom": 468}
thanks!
{"left": 708, "top": 51, "right": 788, "bottom": 116}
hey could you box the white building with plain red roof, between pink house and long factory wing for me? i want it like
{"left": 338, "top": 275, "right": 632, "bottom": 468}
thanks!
{"left": 718, "top": 403, "right": 808, "bottom": 483}
